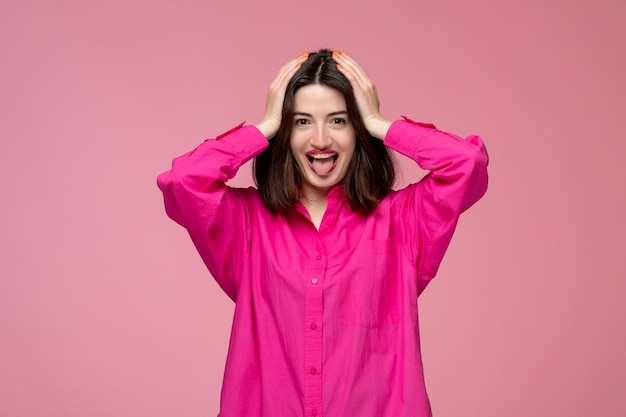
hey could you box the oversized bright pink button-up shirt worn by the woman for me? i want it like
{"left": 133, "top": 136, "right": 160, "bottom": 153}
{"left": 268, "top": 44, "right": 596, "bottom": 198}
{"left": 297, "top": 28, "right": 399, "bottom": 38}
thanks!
{"left": 158, "top": 118, "right": 487, "bottom": 417}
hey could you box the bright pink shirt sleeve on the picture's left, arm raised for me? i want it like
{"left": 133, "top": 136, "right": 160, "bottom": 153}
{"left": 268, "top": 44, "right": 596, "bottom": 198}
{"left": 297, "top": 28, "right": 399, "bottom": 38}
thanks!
{"left": 157, "top": 123, "right": 268, "bottom": 300}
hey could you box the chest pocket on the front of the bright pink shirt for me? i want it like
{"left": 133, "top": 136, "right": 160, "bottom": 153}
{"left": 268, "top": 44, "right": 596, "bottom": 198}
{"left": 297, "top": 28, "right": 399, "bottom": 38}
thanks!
{"left": 339, "top": 240, "right": 402, "bottom": 327}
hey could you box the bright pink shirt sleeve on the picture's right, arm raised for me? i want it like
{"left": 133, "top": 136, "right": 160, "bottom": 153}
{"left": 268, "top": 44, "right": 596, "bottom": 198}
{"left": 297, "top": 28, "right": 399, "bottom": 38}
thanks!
{"left": 385, "top": 117, "right": 489, "bottom": 294}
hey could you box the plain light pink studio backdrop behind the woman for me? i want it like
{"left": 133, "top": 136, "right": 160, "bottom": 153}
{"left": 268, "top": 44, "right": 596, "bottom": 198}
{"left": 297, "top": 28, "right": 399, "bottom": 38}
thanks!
{"left": 0, "top": 0, "right": 626, "bottom": 417}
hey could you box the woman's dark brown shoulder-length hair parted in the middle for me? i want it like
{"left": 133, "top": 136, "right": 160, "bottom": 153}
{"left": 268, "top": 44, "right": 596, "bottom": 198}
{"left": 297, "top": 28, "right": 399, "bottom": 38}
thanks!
{"left": 253, "top": 49, "right": 395, "bottom": 212}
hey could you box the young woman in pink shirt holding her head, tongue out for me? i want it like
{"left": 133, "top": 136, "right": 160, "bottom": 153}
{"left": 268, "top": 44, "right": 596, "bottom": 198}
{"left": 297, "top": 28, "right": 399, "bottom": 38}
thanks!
{"left": 158, "top": 50, "right": 487, "bottom": 417}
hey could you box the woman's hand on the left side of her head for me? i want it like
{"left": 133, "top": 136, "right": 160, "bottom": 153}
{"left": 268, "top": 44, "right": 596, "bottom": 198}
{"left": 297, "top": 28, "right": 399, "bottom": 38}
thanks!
{"left": 255, "top": 52, "right": 309, "bottom": 139}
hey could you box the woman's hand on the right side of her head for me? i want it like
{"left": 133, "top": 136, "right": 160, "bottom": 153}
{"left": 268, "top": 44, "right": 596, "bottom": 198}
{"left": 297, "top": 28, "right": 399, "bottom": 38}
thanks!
{"left": 333, "top": 51, "right": 391, "bottom": 140}
